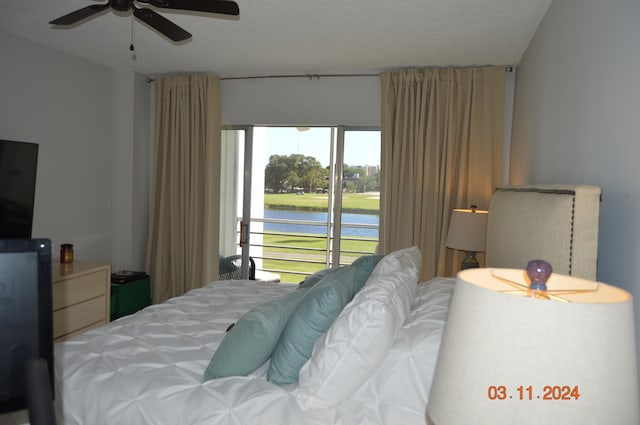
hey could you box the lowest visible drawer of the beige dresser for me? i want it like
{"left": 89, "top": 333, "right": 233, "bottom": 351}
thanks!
{"left": 53, "top": 296, "right": 106, "bottom": 339}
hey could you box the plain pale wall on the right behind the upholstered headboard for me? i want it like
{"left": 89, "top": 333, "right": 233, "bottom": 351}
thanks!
{"left": 511, "top": 0, "right": 640, "bottom": 378}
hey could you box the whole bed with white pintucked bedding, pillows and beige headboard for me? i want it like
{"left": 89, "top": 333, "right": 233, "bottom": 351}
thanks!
{"left": 0, "top": 186, "right": 600, "bottom": 425}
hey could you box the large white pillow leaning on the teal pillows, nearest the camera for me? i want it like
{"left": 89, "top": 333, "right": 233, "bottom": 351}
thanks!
{"left": 296, "top": 247, "right": 421, "bottom": 410}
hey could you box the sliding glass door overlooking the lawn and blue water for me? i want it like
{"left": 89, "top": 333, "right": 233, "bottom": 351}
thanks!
{"left": 220, "top": 127, "right": 380, "bottom": 283}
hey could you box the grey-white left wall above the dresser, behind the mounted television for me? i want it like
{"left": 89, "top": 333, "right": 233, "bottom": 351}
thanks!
{"left": 0, "top": 29, "right": 115, "bottom": 261}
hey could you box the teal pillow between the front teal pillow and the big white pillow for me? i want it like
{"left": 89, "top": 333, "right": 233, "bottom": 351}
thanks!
{"left": 267, "top": 267, "right": 355, "bottom": 385}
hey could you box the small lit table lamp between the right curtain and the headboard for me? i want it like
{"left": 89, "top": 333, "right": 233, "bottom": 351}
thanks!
{"left": 447, "top": 205, "right": 488, "bottom": 270}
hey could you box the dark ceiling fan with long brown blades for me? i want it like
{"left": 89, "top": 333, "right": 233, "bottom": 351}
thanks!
{"left": 49, "top": 0, "right": 240, "bottom": 41}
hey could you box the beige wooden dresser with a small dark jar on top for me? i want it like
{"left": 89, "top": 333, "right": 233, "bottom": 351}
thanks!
{"left": 53, "top": 261, "right": 111, "bottom": 341}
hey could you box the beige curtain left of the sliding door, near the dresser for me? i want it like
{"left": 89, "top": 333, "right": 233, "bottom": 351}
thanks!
{"left": 147, "top": 75, "right": 221, "bottom": 303}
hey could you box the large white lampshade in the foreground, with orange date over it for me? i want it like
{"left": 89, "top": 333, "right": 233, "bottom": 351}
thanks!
{"left": 427, "top": 269, "right": 640, "bottom": 425}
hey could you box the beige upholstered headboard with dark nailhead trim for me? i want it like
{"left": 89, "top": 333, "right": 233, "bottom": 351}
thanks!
{"left": 486, "top": 185, "right": 601, "bottom": 279}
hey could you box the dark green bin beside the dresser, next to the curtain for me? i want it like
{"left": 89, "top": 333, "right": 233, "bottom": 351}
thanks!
{"left": 111, "top": 271, "right": 151, "bottom": 320}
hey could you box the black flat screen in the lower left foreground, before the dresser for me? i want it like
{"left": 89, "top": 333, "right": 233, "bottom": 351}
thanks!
{"left": 0, "top": 239, "right": 54, "bottom": 414}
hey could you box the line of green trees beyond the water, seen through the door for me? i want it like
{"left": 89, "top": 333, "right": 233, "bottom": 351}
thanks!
{"left": 264, "top": 154, "right": 380, "bottom": 193}
